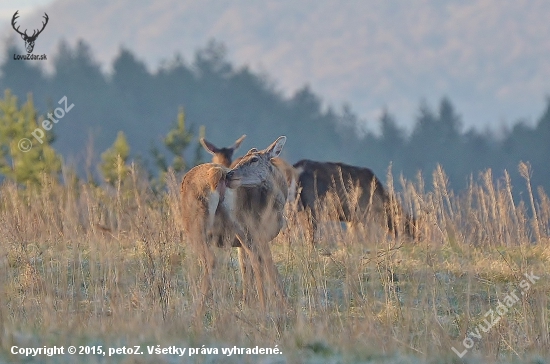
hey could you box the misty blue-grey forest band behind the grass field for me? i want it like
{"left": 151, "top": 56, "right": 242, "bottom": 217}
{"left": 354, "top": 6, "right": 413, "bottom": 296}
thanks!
{"left": 0, "top": 40, "right": 550, "bottom": 192}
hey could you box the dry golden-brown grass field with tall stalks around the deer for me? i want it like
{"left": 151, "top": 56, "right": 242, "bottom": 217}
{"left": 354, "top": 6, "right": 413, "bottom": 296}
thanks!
{"left": 0, "top": 164, "right": 550, "bottom": 364}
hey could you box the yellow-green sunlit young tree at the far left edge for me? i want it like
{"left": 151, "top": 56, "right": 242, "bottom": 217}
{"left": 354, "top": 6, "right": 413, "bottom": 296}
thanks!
{"left": 0, "top": 90, "right": 62, "bottom": 184}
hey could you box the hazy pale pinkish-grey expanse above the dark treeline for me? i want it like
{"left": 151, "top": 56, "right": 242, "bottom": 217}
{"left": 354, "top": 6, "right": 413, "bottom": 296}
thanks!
{"left": 0, "top": 0, "right": 550, "bottom": 133}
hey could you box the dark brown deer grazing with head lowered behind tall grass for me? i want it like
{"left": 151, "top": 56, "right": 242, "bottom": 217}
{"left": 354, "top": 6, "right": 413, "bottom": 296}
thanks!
{"left": 293, "top": 159, "right": 415, "bottom": 246}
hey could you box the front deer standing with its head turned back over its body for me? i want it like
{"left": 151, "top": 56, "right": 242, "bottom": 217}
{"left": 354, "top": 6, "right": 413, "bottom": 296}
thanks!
{"left": 181, "top": 136, "right": 288, "bottom": 316}
